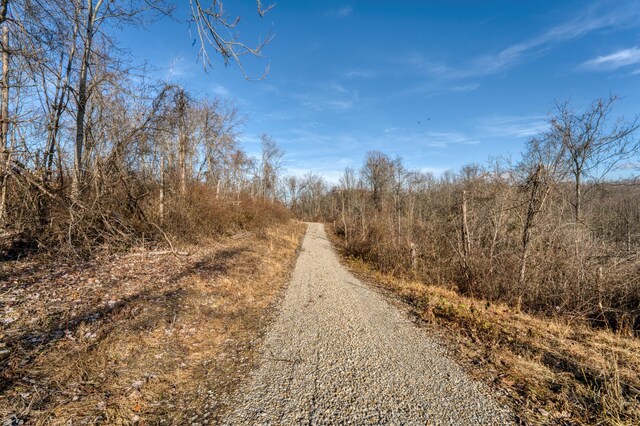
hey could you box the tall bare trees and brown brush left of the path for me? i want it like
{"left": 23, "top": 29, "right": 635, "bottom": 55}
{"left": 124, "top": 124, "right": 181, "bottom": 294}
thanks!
{"left": 0, "top": 0, "right": 286, "bottom": 256}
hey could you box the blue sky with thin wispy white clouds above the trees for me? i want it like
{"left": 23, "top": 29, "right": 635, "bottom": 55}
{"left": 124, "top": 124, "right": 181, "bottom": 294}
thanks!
{"left": 121, "top": 0, "right": 640, "bottom": 181}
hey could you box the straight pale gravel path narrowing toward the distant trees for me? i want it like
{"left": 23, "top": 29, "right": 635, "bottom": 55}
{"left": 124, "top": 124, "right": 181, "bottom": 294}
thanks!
{"left": 225, "top": 224, "right": 513, "bottom": 425}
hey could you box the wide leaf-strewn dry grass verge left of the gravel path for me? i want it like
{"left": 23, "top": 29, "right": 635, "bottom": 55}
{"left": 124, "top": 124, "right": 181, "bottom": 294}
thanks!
{"left": 0, "top": 222, "right": 305, "bottom": 425}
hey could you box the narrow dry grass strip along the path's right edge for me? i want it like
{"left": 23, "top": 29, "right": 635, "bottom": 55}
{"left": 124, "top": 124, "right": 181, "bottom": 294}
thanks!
{"left": 328, "top": 225, "right": 640, "bottom": 425}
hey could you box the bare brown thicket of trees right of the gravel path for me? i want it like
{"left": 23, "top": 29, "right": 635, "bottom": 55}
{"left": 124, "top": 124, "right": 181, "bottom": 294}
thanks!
{"left": 288, "top": 98, "right": 640, "bottom": 331}
